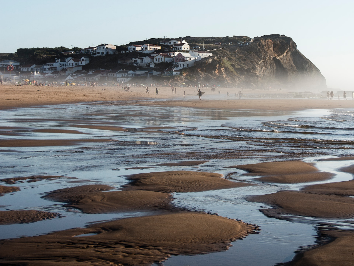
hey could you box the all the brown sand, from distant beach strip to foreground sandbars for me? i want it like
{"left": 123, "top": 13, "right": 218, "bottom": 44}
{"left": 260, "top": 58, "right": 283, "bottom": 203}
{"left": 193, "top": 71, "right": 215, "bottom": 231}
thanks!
{"left": 0, "top": 85, "right": 354, "bottom": 265}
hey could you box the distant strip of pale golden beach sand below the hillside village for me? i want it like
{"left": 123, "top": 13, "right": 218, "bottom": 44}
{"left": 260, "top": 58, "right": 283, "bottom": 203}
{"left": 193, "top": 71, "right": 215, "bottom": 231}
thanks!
{"left": 0, "top": 85, "right": 354, "bottom": 111}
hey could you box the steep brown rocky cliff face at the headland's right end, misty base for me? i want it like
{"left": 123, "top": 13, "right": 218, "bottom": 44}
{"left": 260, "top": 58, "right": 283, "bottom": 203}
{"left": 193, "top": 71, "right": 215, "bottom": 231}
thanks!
{"left": 182, "top": 35, "right": 326, "bottom": 91}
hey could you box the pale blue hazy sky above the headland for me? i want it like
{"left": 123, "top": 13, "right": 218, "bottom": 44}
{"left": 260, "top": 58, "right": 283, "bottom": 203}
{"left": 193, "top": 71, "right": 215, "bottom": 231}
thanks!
{"left": 0, "top": 0, "right": 354, "bottom": 91}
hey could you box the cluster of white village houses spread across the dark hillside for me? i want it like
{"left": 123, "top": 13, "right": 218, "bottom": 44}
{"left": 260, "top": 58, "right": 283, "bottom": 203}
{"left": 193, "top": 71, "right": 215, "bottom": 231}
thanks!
{"left": 0, "top": 40, "right": 212, "bottom": 83}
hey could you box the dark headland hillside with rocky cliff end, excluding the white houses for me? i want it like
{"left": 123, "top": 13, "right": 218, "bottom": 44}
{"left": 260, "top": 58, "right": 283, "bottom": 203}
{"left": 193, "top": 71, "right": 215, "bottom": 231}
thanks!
{"left": 0, "top": 34, "right": 326, "bottom": 91}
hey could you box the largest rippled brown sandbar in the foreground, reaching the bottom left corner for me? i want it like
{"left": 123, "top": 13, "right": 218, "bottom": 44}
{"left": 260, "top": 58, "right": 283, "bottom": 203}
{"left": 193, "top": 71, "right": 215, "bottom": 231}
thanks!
{"left": 0, "top": 212, "right": 254, "bottom": 265}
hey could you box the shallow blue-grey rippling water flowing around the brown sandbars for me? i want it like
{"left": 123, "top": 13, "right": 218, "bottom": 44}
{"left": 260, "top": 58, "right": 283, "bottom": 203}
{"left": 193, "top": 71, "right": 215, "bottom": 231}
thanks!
{"left": 0, "top": 102, "right": 354, "bottom": 265}
